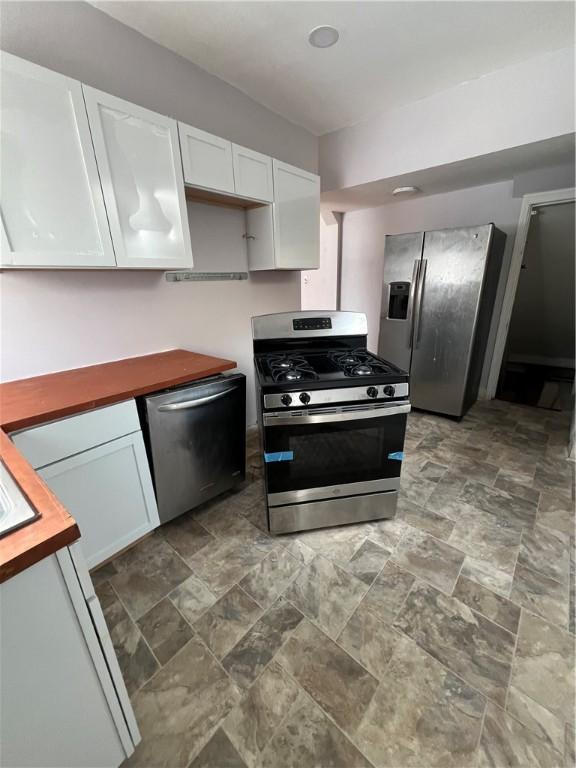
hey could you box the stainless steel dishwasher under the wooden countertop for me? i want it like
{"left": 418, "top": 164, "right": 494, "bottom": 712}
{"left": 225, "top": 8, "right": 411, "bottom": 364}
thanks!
{"left": 138, "top": 373, "right": 246, "bottom": 523}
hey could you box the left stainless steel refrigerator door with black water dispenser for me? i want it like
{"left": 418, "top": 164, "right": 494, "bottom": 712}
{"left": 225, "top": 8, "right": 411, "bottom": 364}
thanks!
{"left": 378, "top": 232, "right": 424, "bottom": 371}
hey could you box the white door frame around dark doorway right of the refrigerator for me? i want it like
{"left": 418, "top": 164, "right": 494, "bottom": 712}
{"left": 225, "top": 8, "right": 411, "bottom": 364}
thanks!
{"left": 486, "top": 187, "right": 576, "bottom": 400}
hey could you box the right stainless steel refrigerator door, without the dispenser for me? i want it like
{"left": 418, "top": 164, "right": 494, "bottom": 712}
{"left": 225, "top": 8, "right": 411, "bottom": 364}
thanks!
{"left": 410, "top": 224, "right": 494, "bottom": 416}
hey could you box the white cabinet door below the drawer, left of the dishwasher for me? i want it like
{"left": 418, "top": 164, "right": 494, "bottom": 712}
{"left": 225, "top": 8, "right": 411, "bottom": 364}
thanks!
{"left": 39, "top": 432, "right": 160, "bottom": 568}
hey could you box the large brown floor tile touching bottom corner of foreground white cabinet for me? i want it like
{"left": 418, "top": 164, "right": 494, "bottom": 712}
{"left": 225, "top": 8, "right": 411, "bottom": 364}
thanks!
{"left": 126, "top": 638, "right": 240, "bottom": 768}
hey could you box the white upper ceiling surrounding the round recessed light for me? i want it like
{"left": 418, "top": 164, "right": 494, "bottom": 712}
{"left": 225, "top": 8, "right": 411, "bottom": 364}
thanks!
{"left": 92, "top": 0, "right": 574, "bottom": 135}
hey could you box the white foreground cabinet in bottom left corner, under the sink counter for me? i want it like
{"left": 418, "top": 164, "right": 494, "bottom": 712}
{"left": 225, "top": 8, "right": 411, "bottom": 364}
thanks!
{"left": 0, "top": 545, "right": 140, "bottom": 768}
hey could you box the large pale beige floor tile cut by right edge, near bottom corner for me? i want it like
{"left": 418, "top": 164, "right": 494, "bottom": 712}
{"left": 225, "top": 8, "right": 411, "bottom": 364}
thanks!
{"left": 510, "top": 611, "right": 574, "bottom": 723}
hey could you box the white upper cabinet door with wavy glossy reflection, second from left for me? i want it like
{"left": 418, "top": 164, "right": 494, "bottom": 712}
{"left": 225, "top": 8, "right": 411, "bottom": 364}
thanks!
{"left": 83, "top": 86, "right": 192, "bottom": 269}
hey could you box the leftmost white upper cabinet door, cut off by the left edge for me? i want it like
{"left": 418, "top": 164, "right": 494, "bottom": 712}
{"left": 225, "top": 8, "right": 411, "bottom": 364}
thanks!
{"left": 0, "top": 53, "right": 116, "bottom": 267}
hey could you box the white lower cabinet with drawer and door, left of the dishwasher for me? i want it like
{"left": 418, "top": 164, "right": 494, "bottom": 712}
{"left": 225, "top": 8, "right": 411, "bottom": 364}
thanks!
{"left": 12, "top": 400, "right": 160, "bottom": 568}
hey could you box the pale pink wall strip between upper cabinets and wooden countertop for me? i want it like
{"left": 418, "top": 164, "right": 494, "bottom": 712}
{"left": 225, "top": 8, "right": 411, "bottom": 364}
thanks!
{"left": 0, "top": 271, "right": 300, "bottom": 424}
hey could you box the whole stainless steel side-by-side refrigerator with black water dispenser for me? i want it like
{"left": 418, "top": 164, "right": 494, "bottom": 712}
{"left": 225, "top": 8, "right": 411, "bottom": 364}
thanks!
{"left": 378, "top": 224, "right": 506, "bottom": 417}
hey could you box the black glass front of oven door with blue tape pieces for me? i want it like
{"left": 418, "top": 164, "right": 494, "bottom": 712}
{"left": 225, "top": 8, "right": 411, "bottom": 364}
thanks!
{"left": 264, "top": 414, "right": 406, "bottom": 493}
